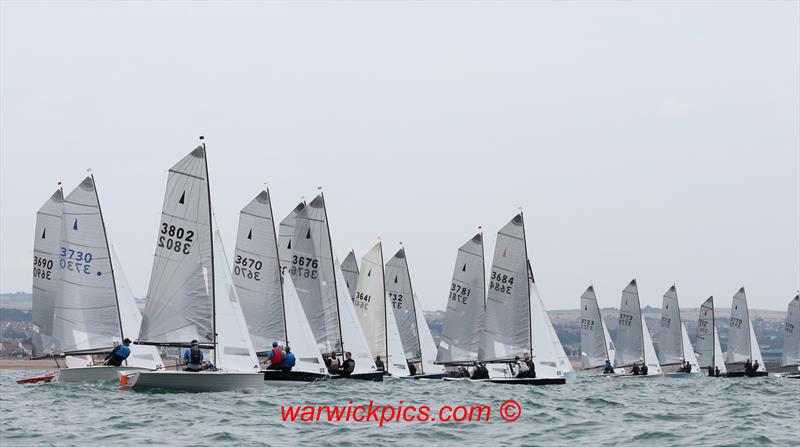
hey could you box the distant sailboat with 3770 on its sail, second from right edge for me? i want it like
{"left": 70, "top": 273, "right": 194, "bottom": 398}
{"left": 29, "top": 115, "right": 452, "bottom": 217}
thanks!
{"left": 725, "top": 287, "right": 767, "bottom": 377}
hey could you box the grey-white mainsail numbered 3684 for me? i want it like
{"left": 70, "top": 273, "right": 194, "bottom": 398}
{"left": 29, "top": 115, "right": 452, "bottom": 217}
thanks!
{"left": 478, "top": 213, "right": 531, "bottom": 361}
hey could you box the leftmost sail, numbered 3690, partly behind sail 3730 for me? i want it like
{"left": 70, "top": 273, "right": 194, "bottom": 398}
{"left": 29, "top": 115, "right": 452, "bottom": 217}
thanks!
{"left": 31, "top": 189, "right": 64, "bottom": 357}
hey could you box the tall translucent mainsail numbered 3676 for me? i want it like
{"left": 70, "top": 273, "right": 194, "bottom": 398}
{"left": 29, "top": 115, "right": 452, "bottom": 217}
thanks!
{"left": 286, "top": 194, "right": 342, "bottom": 352}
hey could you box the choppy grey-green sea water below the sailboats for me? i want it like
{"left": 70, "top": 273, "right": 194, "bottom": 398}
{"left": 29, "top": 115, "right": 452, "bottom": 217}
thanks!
{"left": 0, "top": 371, "right": 800, "bottom": 447}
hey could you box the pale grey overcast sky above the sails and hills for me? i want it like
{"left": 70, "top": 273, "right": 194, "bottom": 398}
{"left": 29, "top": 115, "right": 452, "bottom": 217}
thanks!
{"left": 0, "top": 1, "right": 800, "bottom": 310}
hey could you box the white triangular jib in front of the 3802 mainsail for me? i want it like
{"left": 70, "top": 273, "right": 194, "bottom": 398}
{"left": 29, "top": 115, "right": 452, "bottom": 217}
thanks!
{"left": 214, "top": 226, "right": 259, "bottom": 372}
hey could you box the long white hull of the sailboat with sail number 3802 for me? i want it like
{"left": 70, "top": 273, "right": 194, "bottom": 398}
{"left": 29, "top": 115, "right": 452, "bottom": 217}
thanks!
{"left": 120, "top": 371, "right": 264, "bottom": 392}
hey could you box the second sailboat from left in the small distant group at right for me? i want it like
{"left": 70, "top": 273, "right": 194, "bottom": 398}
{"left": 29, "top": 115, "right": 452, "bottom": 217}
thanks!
{"left": 611, "top": 279, "right": 662, "bottom": 377}
